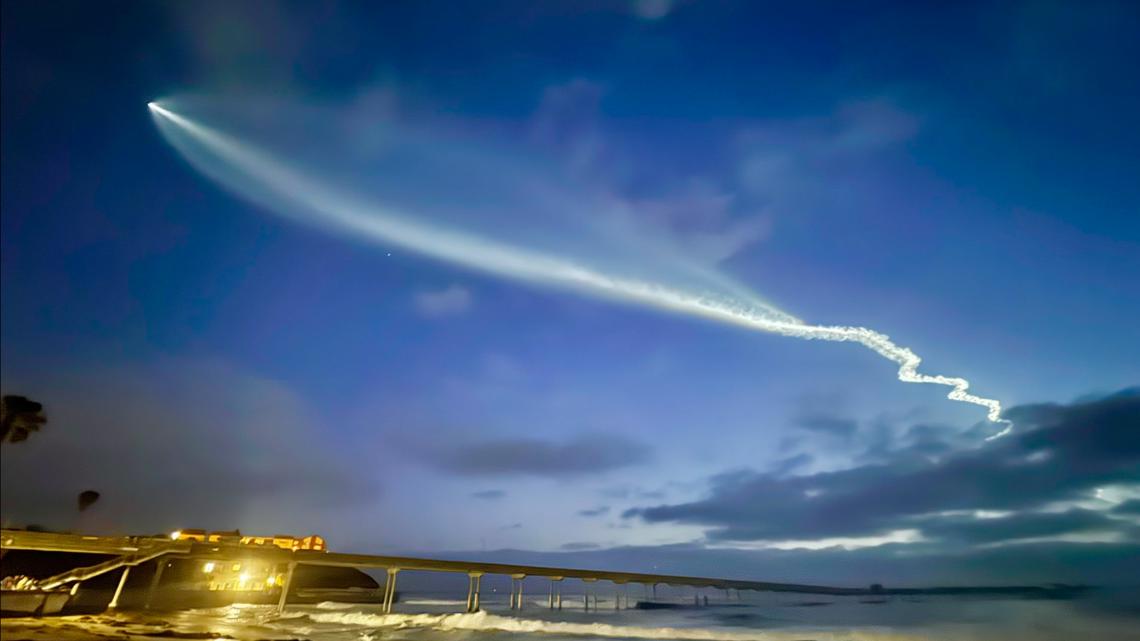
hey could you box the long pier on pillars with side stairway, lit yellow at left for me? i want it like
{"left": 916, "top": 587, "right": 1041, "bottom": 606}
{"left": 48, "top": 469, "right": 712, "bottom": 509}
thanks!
{"left": 0, "top": 529, "right": 868, "bottom": 612}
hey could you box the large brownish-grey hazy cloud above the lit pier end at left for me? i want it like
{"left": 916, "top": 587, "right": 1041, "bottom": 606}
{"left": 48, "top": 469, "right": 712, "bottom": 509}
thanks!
{"left": 2, "top": 359, "right": 378, "bottom": 534}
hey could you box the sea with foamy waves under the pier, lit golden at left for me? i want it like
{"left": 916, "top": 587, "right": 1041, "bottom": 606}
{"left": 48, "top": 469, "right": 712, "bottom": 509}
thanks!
{"left": 2, "top": 590, "right": 1140, "bottom": 641}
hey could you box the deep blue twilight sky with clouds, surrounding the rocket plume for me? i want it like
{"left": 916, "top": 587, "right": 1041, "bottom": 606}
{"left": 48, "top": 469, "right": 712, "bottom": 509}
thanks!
{"left": 0, "top": 0, "right": 1140, "bottom": 583}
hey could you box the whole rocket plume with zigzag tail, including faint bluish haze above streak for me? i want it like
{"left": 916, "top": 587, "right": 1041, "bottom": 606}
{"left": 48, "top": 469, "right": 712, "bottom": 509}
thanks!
{"left": 147, "top": 100, "right": 1012, "bottom": 440}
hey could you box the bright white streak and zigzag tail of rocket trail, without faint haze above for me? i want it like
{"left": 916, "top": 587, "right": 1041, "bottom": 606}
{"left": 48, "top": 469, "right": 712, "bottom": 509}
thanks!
{"left": 148, "top": 103, "right": 1012, "bottom": 440}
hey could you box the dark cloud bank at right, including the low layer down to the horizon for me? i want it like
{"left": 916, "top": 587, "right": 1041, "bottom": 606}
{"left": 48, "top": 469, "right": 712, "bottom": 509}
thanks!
{"left": 606, "top": 388, "right": 1140, "bottom": 584}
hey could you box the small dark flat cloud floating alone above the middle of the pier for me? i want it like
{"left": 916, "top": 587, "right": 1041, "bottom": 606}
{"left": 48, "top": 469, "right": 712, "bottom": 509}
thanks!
{"left": 410, "top": 433, "right": 650, "bottom": 478}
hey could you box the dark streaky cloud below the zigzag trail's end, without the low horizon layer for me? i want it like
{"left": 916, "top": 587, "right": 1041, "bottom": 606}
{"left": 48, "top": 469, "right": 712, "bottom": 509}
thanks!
{"left": 625, "top": 389, "right": 1140, "bottom": 543}
